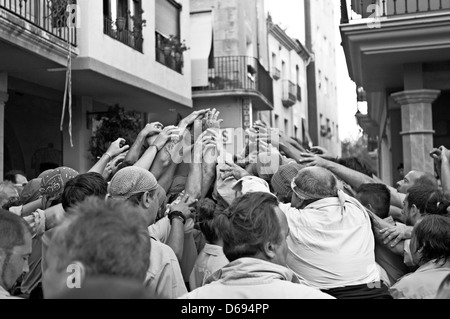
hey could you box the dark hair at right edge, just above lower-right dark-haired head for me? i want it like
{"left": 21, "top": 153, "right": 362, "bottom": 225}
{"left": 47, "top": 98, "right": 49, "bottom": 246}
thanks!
{"left": 408, "top": 184, "right": 450, "bottom": 215}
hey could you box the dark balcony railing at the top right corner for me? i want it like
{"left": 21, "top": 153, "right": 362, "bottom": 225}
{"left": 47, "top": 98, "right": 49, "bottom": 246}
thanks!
{"left": 341, "top": 0, "right": 450, "bottom": 23}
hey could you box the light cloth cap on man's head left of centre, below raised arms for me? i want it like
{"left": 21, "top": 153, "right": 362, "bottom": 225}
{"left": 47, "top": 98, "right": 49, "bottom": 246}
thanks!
{"left": 108, "top": 166, "right": 158, "bottom": 200}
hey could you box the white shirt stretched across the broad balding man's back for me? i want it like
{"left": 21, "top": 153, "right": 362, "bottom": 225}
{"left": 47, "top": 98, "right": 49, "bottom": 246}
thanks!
{"left": 280, "top": 195, "right": 380, "bottom": 289}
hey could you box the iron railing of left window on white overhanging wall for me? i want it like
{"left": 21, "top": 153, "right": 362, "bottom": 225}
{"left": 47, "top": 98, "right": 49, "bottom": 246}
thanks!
{"left": 103, "top": 17, "right": 144, "bottom": 52}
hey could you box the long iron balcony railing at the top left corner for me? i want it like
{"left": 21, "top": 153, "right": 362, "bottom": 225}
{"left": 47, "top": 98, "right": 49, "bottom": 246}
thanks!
{"left": 0, "top": 0, "right": 77, "bottom": 46}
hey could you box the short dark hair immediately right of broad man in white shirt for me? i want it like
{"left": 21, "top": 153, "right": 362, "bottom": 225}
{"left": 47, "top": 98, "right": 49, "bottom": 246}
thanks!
{"left": 357, "top": 184, "right": 391, "bottom": 219}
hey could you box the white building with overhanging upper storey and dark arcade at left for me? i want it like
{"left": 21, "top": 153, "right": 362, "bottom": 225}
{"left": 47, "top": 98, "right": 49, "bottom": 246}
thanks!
{"left": 0, "top": 0, "right": 192, "bottom": 180}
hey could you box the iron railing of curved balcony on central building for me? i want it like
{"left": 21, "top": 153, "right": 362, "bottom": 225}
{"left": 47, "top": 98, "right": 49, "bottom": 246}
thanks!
{"left": 193, "top": 56, "right": 273, "bottom": 104}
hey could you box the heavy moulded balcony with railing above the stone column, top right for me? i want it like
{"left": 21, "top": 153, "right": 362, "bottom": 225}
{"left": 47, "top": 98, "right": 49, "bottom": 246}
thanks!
{"left": 340, "top": 0, "right": 450, "bottom": 92}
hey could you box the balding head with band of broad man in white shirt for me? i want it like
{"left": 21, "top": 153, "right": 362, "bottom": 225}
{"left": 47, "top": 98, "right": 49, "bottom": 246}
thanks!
{"left": 292, "top": 167, "right": 338, "bottom": 208}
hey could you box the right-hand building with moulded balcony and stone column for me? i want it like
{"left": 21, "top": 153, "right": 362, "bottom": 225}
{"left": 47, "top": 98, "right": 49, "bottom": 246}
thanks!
{"left": 340, "top": 0, "right": 450, "bottom": 184}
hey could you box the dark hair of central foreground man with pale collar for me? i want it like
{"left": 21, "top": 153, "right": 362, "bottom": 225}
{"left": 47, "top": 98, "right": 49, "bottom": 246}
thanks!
{"left": 217, "top": 193, "right": 282, "bottom": 262}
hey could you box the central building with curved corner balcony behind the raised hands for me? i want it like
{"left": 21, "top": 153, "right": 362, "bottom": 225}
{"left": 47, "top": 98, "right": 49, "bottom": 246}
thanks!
{"left": 190, "top": 0, "right": 273, "bottom": 144}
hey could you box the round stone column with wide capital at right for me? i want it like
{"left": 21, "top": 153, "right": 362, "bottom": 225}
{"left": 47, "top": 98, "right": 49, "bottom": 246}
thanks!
{"left": 392, "top": 90, "right": 440, "bottom": 174}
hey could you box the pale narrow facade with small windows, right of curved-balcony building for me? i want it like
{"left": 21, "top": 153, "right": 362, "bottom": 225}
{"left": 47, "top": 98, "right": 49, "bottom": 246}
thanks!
{"left": 259, "top": 17, "right": 312, "bottom": 142}
